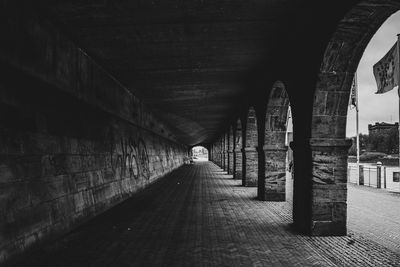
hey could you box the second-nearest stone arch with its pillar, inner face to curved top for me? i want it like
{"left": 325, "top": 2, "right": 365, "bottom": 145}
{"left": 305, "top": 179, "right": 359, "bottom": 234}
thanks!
{"left": 258, "top": 81, "right": 293, "bottom": 201}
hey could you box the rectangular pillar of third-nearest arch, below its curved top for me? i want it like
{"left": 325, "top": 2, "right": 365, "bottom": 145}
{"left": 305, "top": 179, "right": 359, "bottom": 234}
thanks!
{"left": 242, "top": 147, "right": 258, "bottom": 187}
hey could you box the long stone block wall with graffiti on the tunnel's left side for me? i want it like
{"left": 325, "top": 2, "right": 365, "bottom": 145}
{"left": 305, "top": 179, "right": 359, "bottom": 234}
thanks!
{"left": 0, "top": 3, "right": 187, "bottom": 262}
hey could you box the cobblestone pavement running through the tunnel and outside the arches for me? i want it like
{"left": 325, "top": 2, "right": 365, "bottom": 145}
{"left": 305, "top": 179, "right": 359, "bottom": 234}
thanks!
{"left": 7, "top": 162, "right": 400, "bottom": 266}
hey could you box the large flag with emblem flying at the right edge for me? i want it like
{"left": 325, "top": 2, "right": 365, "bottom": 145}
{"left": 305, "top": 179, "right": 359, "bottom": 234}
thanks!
{"left": 373, "top": 42, "right": 400, "bottom": 94}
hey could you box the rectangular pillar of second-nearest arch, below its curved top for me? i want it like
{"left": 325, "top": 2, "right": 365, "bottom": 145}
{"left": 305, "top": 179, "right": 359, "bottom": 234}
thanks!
{"left": 258, "top": 143, "right": 288, "bottom": 201}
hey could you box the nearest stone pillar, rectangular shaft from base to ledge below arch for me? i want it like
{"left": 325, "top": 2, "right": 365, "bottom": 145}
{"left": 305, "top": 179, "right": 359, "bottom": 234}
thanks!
{"left": 310, "top": 139, "right": 351, "bottom": 236}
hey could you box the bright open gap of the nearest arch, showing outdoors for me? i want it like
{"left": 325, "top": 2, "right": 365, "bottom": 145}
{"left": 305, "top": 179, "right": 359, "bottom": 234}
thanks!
{"left": 346, "top": 12, "right": 400, "bottom": 248}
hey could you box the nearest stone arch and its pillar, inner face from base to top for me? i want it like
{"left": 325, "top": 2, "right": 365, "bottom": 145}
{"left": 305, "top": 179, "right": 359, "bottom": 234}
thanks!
{"left": 308, "top": 0, "right": 400, "bottom": 235}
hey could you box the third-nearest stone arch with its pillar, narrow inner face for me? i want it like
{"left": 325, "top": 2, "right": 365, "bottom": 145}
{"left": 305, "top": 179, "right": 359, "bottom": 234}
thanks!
{"left": 242, "top": 107, "right": 258, "bottom": 187}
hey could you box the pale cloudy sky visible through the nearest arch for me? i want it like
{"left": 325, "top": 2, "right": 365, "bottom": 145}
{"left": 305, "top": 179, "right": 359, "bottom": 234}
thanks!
{"left": 346, "top": 11, "right": 400, "bottom": 137}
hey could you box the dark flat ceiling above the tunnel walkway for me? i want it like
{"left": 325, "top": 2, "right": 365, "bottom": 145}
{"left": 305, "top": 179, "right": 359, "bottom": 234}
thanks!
{"left": 41, "top": 0, "right": 295, "bottom": 145}
